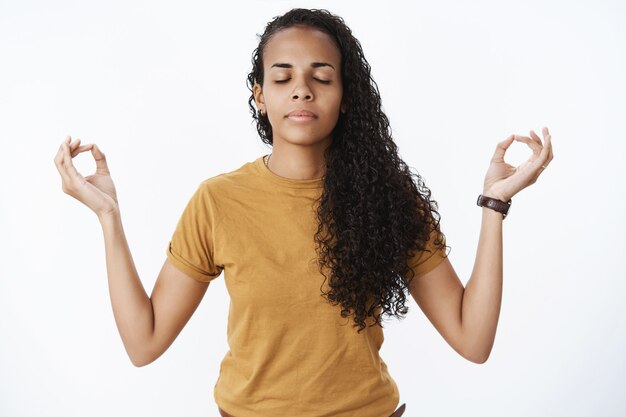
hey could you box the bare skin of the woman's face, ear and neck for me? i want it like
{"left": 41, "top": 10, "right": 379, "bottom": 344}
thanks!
{"left": 253, "top": 25, "right": 346, "bottom": 179}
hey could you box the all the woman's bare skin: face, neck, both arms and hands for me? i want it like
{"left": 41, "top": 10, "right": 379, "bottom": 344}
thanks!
{"left": 54, "top": 27, "right": 553, "bottom": 366}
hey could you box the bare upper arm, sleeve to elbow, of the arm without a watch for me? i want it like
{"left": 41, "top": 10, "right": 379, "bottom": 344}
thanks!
{"left": 143, "top": 258, "right": 209, "bottom": 365}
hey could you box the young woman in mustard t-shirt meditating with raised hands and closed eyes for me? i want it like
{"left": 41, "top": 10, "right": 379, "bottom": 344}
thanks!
{"left": 55, "top": 9, "right": 553, "bottom": 417}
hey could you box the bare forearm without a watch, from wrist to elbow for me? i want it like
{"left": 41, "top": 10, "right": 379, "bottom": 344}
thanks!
{"left": 99, "top": 208, "right": 154, "bottom": 365}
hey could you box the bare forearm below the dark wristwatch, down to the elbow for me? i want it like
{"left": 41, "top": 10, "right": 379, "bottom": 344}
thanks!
{"left": 461, "top": 205, "right": 503, "bottom": 363}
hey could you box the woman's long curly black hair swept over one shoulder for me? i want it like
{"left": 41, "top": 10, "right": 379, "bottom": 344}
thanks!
{"left": 247, "top": 8, "right": 448, "bottom": 333}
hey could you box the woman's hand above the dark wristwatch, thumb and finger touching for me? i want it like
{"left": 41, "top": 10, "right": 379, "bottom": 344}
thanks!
{"left": 483, "top": 127, "right": 553, "bottom": 201}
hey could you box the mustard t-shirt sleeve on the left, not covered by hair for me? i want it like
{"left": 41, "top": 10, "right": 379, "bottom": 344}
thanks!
{"left": 166, "top": 183, "right": 224, "bottom": 282}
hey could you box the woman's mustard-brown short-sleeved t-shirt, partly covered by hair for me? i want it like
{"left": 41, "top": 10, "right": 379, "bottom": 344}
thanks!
{"left": 167, "top": 157, "right": 445, "bottom": 417}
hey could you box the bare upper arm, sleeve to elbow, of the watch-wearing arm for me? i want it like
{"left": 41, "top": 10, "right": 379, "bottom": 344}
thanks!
{"left": 409, "top": 257, "right": 465, "bottom": 357}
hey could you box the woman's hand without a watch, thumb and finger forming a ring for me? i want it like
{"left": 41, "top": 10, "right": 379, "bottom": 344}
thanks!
{"left": 54, "top": 136, "right": 119, "bottom": 218}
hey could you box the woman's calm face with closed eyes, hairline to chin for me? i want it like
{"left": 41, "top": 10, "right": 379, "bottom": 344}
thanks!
{"left": 253, "top": 26, "right": 343, "bottom": 145}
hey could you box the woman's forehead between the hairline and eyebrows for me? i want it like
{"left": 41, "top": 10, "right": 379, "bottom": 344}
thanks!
{"left": 263, "top": 26, "right": 341, "bottom": 68}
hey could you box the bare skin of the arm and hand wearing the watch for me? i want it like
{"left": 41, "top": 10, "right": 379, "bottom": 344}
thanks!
{"left": 409, "top": 127, "right": 554, "bottom": 364}
